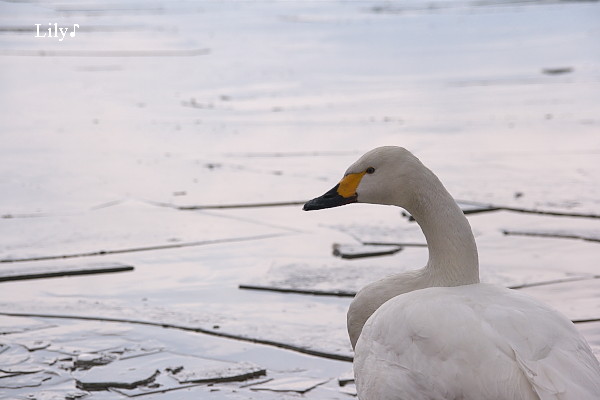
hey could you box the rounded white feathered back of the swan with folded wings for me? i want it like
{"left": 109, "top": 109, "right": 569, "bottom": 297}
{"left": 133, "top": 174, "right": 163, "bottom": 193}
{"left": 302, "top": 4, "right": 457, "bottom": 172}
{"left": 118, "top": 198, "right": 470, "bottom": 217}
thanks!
{"left": 354, "top": 284, "right": 600, "bottom": 400}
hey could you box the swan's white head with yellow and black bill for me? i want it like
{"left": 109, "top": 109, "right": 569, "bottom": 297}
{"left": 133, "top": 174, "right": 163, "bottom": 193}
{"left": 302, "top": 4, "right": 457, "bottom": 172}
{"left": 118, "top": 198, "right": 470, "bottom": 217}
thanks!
{"left": 304, "top": 146, "right": 424, "bottom": 211}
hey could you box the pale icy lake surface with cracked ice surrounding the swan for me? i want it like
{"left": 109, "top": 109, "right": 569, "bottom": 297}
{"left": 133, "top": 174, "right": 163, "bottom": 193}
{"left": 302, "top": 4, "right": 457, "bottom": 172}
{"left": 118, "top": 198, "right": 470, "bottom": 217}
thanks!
{"left": 0, "top": 0, "right": 600, "bottom": 399}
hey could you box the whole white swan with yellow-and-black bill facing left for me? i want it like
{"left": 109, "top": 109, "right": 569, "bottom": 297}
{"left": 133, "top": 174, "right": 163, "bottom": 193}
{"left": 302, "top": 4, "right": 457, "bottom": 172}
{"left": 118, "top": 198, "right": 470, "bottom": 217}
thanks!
{"left": 304, "top": 146, "right": 600, "bottom": 400}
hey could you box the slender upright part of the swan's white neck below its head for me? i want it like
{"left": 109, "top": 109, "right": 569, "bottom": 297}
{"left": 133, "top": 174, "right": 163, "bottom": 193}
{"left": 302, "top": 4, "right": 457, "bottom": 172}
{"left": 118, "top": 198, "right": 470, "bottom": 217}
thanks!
{"left": 408, "top": 170, "right": 479, "bottom": 286}
